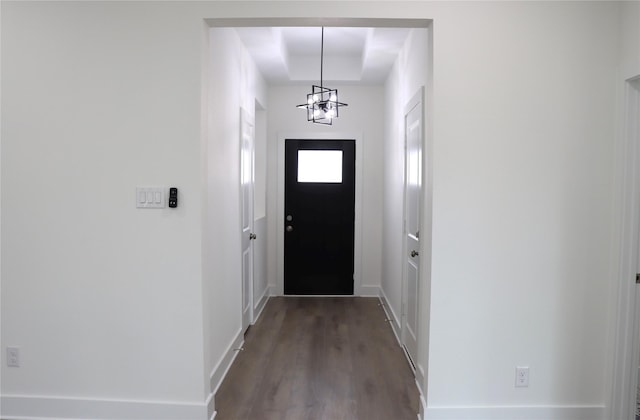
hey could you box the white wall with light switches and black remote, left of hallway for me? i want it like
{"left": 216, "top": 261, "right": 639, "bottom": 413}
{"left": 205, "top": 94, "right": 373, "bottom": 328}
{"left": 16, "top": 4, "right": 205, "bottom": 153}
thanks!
{"left": 2, "top": 2, "right": 205, "bottom": 418}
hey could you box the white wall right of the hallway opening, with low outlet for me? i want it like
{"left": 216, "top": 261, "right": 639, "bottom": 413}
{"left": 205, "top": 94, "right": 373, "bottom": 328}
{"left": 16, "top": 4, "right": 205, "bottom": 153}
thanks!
{"left": 428, "top": 3, "right": 618, "bottom": 418}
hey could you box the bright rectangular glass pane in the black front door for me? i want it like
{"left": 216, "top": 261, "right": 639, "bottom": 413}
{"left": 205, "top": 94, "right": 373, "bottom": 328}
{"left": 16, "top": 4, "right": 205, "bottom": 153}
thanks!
{"left": 298, "top": 150, "right": 342, "bottom": 184}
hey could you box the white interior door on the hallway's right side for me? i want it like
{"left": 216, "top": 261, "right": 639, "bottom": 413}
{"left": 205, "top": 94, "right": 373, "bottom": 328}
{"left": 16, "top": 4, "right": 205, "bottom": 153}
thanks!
{"left": 402, "top": 89, "right": 423, "bottom": 366}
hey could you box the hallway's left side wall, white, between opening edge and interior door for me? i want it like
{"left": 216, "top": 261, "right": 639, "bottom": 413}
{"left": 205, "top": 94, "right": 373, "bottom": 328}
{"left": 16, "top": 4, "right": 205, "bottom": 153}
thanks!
{"left": 202, "top": 28, "right": 267, "bottom": 404}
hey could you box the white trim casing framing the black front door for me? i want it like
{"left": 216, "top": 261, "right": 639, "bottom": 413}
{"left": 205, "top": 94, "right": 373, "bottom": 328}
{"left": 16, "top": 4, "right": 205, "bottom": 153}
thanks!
{"left": 276, "top": 132, "right": 364, "bottom": 296}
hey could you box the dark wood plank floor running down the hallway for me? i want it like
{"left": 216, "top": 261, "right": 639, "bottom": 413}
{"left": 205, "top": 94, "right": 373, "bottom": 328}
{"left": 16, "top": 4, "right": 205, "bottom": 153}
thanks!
{"left": 215, "top": 297, "right": 418, "bottom": 420}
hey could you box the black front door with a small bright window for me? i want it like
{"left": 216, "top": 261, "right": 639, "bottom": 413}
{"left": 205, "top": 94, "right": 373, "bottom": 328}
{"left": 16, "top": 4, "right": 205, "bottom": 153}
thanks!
{"left": 283, "top": 140, "right": 356, "bottom": 295}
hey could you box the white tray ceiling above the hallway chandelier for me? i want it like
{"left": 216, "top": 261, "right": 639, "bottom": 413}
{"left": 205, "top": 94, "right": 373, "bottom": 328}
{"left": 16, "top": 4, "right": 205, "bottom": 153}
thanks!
{"left": 236, "top": 27, "right": 411, "bottom": 84}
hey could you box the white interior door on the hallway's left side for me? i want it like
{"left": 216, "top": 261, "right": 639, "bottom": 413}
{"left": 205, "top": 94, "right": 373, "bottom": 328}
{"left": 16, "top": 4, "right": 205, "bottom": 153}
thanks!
{"left": 240, "top": 109, "right": 255, "bottom": 331}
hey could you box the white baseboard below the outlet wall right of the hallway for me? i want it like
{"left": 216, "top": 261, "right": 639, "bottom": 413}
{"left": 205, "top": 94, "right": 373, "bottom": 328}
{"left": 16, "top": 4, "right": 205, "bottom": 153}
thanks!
{"left": 422, "top": 405, "right": 605, "bottom": 420}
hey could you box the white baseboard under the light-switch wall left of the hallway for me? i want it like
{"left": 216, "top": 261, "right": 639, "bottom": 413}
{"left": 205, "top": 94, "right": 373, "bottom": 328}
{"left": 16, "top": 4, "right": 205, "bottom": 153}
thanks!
{"left": 0, "top": 395, "right": 207, "bottom": 420}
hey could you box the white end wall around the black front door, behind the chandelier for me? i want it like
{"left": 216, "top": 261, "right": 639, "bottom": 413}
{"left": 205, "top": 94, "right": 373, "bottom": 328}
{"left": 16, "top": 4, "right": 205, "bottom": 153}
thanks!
{"left": 267, "top": 85, "right": 384, "bottom": 296}
